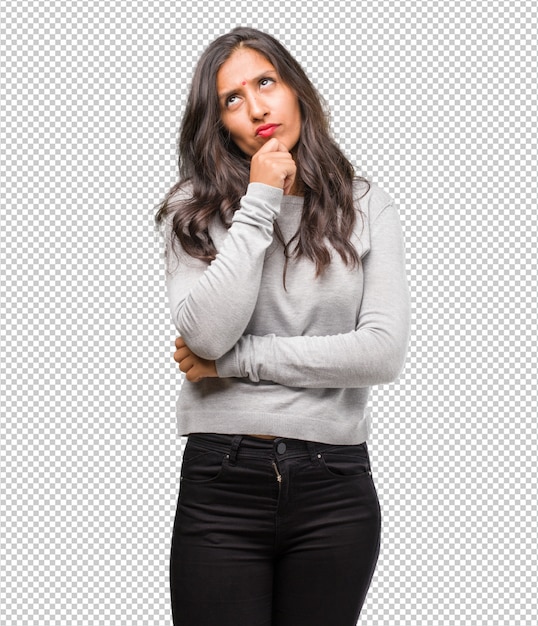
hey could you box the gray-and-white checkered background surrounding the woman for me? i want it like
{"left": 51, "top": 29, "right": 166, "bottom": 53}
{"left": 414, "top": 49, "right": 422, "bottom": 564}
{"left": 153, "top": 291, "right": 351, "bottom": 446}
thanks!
{"left": 0, "top": 0, "right": 538, "bottom": 626}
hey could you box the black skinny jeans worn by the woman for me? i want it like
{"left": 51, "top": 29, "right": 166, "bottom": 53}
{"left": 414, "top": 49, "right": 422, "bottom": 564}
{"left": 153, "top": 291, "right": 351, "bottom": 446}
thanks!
{"left": 170, "top": 434, "right": 381, "bottom": 626}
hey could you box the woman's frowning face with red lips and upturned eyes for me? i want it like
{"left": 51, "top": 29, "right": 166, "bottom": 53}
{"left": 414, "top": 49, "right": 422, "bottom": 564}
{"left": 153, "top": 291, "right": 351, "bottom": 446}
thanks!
{"left": 217, "top": 48, "right": 301, "bottom": 156}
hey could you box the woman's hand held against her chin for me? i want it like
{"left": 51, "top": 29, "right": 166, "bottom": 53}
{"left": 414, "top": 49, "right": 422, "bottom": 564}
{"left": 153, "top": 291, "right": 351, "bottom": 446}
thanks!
{"left": 250, "top": 137, "right": 297, "bottom": 195}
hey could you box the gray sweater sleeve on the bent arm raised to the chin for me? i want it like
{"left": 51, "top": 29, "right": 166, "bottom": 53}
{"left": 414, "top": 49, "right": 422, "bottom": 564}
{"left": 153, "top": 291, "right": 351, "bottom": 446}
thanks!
{"left": 166, "top": 183, "right": 283, "bottom": 359}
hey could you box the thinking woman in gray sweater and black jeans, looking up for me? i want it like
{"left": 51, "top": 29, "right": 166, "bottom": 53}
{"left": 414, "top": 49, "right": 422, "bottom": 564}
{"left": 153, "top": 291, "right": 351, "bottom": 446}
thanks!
{"left": 157, "top": 28, "right": 409, "bottom": 626}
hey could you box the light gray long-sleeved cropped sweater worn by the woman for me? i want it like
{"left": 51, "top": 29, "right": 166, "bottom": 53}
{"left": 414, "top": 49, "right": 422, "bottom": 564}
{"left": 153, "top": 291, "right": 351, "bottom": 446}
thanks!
{"left": 161, "top": 183, "right": 410, "bottom": 444}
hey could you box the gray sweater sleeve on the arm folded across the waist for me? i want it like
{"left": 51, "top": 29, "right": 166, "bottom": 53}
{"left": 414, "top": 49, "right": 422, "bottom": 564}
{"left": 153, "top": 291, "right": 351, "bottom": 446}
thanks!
{"left": 217, "top": 204, "right": 410, "bottom": 388}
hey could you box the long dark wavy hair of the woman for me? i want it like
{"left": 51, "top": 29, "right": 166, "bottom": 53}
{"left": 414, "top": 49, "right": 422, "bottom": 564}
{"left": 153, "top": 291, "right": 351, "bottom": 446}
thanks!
{"left": 155, "top": 28, "right": 369, "bottom": 275}
